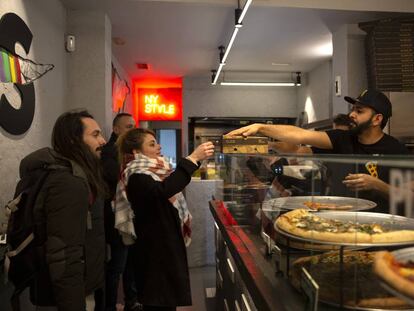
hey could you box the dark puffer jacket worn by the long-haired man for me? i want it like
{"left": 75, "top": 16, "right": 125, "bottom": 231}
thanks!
{"left": 20, "top": 148, "right": 105, "bottom": 311}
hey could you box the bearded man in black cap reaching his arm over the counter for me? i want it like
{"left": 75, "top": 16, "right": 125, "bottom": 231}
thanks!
{"left": 227, "top": 90, "right": 408, "bottom": 211}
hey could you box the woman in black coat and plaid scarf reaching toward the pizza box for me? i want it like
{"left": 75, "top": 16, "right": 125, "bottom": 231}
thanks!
{"left": 115, "top": 129, "right": 214, "bottom": 311}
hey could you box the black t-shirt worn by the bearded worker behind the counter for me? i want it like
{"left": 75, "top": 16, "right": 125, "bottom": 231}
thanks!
{"left": 315, "top": 130, "right": 409, "bottom": 212}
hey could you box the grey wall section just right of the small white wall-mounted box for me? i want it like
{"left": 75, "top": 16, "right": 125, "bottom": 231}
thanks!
{"left": 67, "top": 10, "right": 112, "bottom": 135}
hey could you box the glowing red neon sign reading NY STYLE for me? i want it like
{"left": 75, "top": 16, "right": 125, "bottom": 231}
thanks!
{"left": 137, "top": 88, "right": 182, "bottom": 121}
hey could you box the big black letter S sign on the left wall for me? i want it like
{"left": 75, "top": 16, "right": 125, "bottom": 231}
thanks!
{"left": 0, "top": 13, "right": 35, "bottom": 135}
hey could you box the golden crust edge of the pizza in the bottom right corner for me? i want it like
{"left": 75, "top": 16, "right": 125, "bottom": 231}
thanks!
{"left": 374, "top": 251, "right": 414, "bottom": 298}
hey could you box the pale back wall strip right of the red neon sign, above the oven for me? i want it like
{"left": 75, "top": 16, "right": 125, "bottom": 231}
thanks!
{"left": 182, "top": 76, "right": 297, "bottom": 154}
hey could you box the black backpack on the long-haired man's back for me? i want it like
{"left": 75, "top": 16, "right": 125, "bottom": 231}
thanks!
{"left": 6, "top": 165, "right": 69, "bottom": 311}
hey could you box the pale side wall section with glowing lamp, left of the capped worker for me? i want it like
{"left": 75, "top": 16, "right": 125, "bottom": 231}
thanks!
{"left": 298, "top": 60, "right": 332, "bottom": 123}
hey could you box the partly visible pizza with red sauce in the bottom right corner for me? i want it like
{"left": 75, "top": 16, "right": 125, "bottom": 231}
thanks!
{"left": 374, "top": 251, "right": 414, "bottom": 299}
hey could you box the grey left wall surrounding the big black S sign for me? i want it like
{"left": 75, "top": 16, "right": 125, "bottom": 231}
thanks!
{"left": 0, "top": 0, "right": 67, "bottom": 210}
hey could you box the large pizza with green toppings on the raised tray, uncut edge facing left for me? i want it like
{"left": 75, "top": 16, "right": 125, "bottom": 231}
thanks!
{"left": 275, "top": 209, "right": 414, "bottom": 244}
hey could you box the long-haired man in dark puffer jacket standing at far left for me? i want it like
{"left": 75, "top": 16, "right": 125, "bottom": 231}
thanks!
{"left": 20, "top": 110, "right": 105, "bottom": 311}
